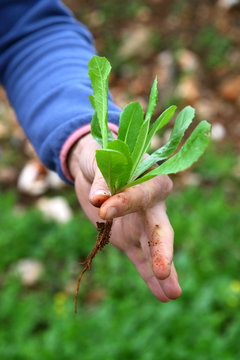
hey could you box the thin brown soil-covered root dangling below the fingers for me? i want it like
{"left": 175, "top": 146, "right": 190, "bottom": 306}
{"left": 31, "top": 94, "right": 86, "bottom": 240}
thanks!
{"left": 75, "top": 220, "right": 113, "bottom": 314}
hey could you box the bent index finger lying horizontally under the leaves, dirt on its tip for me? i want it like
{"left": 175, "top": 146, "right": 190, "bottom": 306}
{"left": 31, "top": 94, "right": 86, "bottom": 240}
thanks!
{"left": 99, "top": 175, "right": 172, "bottom": 220}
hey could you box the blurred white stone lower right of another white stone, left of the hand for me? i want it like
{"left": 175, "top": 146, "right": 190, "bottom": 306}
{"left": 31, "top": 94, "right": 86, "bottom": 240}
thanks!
{"left": 36, "top": 196, "right": 73, "bottom": 224}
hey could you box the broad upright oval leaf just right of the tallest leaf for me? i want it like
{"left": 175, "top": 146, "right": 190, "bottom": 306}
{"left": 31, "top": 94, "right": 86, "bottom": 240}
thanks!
{"left": 118, "top": 102, "right": 144, "bottom": 153}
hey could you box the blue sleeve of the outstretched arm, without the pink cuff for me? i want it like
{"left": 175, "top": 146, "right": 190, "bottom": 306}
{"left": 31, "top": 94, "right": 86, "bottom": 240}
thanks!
{"left": 0, "top": 0, "right": 120, "bottom": 181}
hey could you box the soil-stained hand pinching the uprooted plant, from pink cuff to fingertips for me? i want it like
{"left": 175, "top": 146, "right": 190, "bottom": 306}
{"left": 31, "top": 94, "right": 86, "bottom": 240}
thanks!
{"left": 68, "top": 134, "right": 181, "bottom": 302}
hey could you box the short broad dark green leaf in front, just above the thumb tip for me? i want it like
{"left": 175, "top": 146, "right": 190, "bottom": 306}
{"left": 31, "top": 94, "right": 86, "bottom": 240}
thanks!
{"left": 96, "top": 146, "right": 131, "bottom": 195}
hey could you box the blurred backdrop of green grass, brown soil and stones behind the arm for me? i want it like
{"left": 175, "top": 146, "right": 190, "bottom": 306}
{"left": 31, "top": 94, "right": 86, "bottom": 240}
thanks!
{"left": 0, "top": 0, "right": 240, "bottom": 360}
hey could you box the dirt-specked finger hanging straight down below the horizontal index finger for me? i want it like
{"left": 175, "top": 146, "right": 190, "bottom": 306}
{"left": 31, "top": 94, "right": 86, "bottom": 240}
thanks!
{"left": 145, "top": 202, "right": 174, "bottom": 280}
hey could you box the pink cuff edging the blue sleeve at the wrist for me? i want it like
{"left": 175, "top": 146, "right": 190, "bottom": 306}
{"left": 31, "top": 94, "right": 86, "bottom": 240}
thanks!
{"left": 60, "top": 123, "right": 118, "bottom": 183}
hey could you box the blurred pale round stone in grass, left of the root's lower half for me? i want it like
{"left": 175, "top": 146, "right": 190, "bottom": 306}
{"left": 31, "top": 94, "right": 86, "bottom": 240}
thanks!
{"left": 14, "top": 259, "right": 44, "bottom": 286}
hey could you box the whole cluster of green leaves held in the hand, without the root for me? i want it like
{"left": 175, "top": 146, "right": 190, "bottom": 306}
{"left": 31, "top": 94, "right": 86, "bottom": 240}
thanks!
{"left": 89, "top": 56, "right": 211, "bottom": 195}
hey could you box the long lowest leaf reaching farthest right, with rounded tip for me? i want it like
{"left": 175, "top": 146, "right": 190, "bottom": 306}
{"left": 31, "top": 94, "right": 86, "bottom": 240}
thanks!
{"left": 126, "top": 121, "right": 211, "bottom": 187}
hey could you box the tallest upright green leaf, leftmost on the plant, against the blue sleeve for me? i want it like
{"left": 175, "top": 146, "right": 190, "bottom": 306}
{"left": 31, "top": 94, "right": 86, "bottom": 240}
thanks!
{"left": 88, "top": 55, "right": 111, "bottom": 148}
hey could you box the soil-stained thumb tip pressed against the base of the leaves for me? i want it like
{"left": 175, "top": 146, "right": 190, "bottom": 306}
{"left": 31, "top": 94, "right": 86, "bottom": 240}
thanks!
{"left": 89, "top": 168, "right": 111, "bottom": 207}
